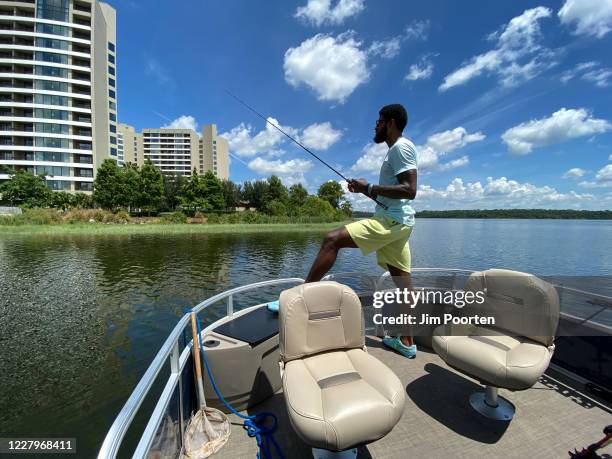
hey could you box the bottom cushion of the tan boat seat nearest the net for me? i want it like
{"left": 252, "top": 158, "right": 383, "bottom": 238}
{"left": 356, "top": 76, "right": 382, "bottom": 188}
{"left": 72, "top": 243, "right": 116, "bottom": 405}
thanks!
{"left": 283, "top": 349, "right": 405, "bottom": 451}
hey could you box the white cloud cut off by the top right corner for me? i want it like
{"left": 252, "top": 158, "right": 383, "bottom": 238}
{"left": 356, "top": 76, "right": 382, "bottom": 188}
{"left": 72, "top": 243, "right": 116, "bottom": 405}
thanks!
{"left": 558, "top": 0, "right": 612, "bottom": 38}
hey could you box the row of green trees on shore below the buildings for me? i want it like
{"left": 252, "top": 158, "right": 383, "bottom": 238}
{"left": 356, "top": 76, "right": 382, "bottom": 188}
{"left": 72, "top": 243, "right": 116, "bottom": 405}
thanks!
{"left": 0, "top": 159, "right": 352, "bottom": 219}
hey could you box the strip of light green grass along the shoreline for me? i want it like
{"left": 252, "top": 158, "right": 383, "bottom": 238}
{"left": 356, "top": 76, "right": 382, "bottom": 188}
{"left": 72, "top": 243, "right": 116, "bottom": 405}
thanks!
{"left": 0, "top": 222, "right": 347, "bottom": 237}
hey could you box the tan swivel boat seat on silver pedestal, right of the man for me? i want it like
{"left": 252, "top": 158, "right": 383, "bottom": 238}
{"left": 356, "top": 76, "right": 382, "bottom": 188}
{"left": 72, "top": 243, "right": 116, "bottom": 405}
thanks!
{"left": 432, "top": 269, "right": 559, "bottom": 420}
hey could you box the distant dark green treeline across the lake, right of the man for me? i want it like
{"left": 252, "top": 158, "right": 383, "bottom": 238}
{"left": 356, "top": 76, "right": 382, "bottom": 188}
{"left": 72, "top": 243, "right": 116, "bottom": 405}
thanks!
{"left": 416, "top": 209, "right": 612, "bottom": 220}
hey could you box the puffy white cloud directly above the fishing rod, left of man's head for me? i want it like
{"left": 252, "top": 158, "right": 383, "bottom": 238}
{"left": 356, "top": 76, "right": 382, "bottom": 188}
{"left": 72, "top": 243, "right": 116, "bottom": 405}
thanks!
{"left": 284, "top": 32, "right": 370, "bottom": 103}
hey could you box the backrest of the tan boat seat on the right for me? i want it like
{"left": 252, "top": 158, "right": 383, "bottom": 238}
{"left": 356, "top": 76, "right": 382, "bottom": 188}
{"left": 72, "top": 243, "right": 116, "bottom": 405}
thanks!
{"left": 465, "top": 269, "right": 559, "bottom": 346}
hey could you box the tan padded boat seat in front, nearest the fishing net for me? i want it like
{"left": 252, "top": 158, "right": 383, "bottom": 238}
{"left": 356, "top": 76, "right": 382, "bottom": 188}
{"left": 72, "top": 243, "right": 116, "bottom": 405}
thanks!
{"left": 279, "top": 282, "right": 405, "bottom": 451}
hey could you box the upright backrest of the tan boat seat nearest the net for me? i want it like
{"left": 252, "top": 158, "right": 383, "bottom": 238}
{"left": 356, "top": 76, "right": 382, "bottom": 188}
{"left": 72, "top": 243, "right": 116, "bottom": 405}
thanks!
{"left": 279, "top": 281, "right": 365, "bottom": 362}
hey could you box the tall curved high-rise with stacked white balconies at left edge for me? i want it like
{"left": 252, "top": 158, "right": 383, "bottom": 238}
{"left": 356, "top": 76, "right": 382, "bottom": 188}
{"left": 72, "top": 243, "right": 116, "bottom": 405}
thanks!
{"left": 0, "top": 0, "right": 118, "bottom": 191}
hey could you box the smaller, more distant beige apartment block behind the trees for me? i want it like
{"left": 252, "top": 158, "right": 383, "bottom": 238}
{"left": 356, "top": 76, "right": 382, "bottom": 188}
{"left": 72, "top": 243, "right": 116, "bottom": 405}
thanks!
{"left": 117, "top": 123, "right": 229, "bottom": 180}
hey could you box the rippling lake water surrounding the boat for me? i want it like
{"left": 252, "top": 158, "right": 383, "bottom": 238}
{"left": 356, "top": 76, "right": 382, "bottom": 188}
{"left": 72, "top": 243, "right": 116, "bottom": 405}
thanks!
{"left": 0, "top": 219, "right": 612, "bottom": 457}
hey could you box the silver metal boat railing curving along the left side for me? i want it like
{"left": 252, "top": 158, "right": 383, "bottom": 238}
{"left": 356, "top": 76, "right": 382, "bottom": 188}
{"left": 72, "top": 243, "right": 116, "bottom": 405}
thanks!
{"left": 98, "top": 277, "right": 304, "bottom": 459}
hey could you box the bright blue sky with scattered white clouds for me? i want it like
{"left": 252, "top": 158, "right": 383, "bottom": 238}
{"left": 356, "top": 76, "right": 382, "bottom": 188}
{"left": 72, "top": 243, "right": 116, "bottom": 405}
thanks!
{"left": 109, "top": 0, "right": 612, "bottom": 209}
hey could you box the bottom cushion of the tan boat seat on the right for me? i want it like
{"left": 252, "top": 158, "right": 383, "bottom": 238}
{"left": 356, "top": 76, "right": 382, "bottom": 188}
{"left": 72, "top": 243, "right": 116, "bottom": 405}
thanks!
{"left": 432, "top": 325, "right": 553, "bottom": 390}
